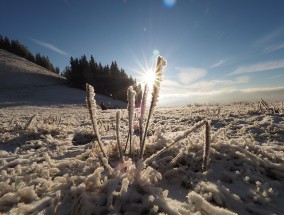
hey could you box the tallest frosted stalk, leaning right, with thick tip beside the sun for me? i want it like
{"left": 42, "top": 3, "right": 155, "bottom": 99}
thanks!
{"left": 139, "top": 56, "right": 167, "bottom": 158}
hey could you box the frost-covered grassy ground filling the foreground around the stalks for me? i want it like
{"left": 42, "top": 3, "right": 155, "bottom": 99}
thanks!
{"left": 0, "top": 105, "right": 284, "bottom": 215}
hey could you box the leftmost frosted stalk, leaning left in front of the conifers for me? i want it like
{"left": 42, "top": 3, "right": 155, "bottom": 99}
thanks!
{"left": 86, "top": 84, "right": 107, "bottom": 157}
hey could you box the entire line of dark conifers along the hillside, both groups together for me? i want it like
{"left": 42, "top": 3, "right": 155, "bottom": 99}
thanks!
{"left": 0, "top": 35, "right": 142, "bottom": 101}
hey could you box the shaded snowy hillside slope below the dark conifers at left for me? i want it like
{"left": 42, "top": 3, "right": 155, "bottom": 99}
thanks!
{"left": 0, "top": 49, "right": 126, "bottom": 107}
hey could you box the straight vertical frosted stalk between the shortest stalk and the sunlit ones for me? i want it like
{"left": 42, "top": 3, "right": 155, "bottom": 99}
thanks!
{"left": 125, "top": 86, "right": 136, "bottom": 154}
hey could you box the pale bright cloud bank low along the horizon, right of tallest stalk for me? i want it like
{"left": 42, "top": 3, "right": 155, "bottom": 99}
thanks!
{"left": 160, "top": 79, "right": 284, "bottom": 106}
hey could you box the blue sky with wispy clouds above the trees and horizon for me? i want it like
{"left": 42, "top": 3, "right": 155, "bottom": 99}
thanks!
{"left": 0, "top": 0, "right": 284, "bottom": 105}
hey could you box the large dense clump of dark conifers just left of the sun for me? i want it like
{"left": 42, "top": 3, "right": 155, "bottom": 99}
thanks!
{"left": 63, "top": 55, "right": 141, "bottom": 101}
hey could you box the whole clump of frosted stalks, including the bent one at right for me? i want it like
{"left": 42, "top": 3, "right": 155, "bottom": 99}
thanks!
{"left": 86, "top": 56, "right": 210, "bottom": 171}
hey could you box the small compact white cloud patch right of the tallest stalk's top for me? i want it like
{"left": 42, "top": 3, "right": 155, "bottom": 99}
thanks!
{"left": 175, "top": 67, "right": 207, "bottom": 84}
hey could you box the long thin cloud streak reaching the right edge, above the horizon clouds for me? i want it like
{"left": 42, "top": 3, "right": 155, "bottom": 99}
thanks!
{"left": 228, "top": 59, "right": 284, "bottom": 75}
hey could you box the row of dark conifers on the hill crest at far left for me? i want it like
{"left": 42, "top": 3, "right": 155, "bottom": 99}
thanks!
{"left": 0, "top": 35, "right": 60, "bottom": 74}
